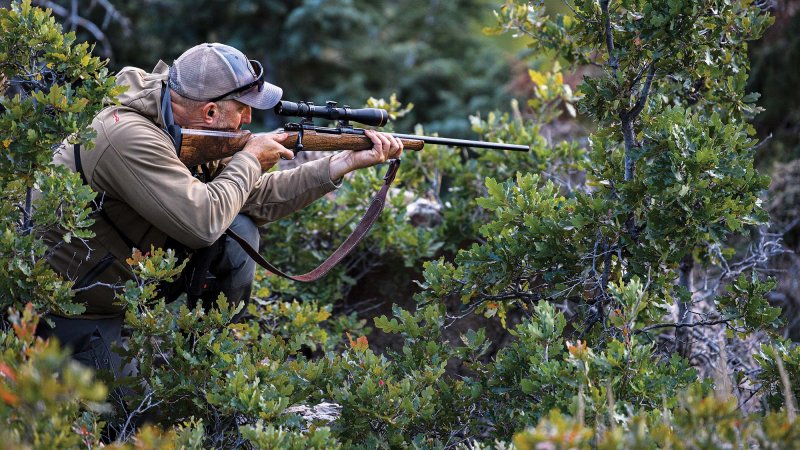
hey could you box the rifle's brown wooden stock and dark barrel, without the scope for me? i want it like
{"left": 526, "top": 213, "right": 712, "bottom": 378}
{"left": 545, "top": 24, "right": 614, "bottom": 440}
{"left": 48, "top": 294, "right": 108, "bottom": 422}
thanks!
{"left": 178, "top": 124, "right": 530, "bottom": 167}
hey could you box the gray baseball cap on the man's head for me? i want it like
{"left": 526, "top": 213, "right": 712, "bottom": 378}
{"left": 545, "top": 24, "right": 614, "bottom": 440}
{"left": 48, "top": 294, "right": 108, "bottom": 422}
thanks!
{"left": 169, "top": 43, "right": 283, "bottom": 109}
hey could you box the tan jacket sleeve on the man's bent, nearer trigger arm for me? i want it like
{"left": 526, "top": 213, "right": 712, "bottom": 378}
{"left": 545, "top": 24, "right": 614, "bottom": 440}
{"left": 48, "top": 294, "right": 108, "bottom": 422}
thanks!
{"left": 92, "top": 118, "right": 261, "bottom": 248}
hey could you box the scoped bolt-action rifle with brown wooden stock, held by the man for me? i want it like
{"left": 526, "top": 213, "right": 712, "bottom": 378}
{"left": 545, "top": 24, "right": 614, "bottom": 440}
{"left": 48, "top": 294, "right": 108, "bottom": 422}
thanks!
{"left": 176, "top": 101, "right": 530, "bottom": 167}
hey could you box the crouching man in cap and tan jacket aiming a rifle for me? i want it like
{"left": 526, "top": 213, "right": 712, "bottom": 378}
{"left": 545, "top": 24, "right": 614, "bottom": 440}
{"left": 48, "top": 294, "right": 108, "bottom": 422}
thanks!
{"left": 41, "top": 43, "right": 403, "bottom": 372}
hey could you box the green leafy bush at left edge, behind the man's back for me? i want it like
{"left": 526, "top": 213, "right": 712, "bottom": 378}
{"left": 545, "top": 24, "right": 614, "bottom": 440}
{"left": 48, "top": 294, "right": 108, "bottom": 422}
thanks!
{"left": 0, "top": 1, "right": 122, "bottom": 314}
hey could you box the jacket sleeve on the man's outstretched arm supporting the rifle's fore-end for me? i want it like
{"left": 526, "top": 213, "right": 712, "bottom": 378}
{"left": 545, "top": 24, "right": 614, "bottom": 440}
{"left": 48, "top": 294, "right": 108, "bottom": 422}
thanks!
{"left": 236, "top": 157, "right": 341, "bottom": 226}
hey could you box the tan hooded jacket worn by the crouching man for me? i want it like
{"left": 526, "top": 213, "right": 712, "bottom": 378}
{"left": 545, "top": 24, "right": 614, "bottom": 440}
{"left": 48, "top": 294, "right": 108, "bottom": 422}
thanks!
{"left": 45, "top": 62, "right": 337, "bottom": 318}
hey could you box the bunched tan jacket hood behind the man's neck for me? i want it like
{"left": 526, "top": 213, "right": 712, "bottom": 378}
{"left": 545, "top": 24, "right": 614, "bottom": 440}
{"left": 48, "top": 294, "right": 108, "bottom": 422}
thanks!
{"left": 117, "top": 61, "right": 169, "bottom": 128}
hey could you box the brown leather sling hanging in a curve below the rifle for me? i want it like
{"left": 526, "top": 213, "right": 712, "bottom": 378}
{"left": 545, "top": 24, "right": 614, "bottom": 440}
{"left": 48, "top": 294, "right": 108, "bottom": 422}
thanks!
{"left": 225, "top": 159, "right": 400, "bottom": 283}
